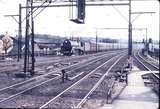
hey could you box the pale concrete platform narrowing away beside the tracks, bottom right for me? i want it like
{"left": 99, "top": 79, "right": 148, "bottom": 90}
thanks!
{"left": 99, "top": 67, "right": 159, "bottom": 109}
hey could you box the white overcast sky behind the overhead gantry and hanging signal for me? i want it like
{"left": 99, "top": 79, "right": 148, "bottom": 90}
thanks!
{"left": 0, "top": 0, "right": 159, "bottom": 40}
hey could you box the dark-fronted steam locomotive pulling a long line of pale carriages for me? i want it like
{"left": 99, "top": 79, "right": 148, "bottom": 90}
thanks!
{"left": 60, "top": 39, "right": 128, "bottom": 56}
